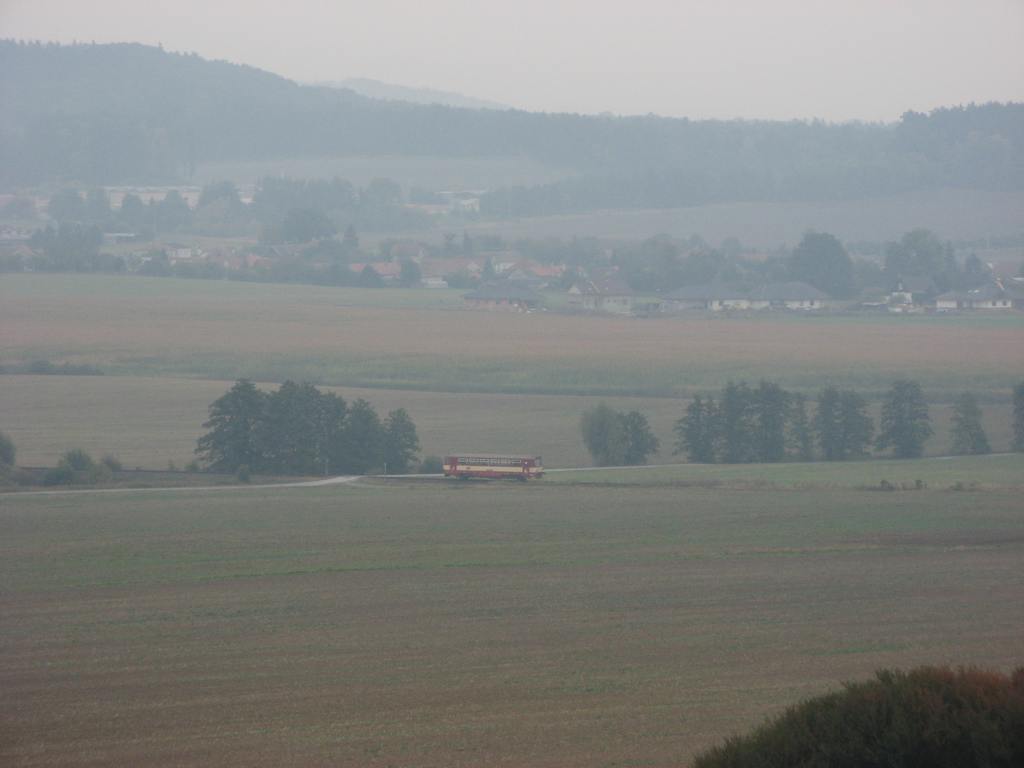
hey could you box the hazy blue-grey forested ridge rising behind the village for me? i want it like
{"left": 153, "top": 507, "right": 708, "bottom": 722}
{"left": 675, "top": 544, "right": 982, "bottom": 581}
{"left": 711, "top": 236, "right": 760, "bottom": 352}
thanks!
{"left": 0, "top": 41, "right": 1024, "bottom": 213}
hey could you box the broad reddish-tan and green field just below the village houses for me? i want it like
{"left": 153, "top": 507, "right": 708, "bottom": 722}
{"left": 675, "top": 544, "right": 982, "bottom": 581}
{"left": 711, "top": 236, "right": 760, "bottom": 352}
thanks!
{"left": 0, "top": 275, "right": 1024, "bottom": 397}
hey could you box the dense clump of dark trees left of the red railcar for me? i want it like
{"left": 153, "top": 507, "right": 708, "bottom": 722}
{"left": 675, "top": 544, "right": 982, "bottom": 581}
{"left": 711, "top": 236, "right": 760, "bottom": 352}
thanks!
{"left": 196, "top": 379, "right": 420, "bottom": 475}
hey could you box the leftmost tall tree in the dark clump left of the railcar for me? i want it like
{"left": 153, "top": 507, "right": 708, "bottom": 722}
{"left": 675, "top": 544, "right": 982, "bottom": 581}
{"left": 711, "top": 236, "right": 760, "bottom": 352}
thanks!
{"left": 196, "top": 379, "right": 266, "bottom": 472}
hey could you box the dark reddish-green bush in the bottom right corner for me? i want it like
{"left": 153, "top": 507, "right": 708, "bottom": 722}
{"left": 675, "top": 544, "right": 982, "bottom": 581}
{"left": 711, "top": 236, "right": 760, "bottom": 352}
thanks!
{"left": 693, "top": 667, "right": 1024, "bottom": 768}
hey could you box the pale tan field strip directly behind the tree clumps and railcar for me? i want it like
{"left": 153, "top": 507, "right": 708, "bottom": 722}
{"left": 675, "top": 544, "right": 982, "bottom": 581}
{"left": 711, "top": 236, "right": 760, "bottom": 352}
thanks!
{"left": 0, "top": 376, "right": 1012, "bottom": 471}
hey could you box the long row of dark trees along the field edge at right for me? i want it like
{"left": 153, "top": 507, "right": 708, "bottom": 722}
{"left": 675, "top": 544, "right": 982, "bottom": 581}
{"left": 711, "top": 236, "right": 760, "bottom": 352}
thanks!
{"left": 675, "top": 380, "right": 991, "bottom": 464}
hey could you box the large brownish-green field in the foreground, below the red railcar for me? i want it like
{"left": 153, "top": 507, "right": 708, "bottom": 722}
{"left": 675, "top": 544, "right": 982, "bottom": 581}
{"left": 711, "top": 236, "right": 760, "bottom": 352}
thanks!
{"left": 0, "top": 481, "right": 1024, "bottom": 766}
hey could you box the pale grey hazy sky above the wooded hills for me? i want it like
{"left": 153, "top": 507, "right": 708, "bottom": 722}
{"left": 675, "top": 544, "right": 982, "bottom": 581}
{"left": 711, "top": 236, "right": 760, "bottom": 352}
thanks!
{"left": 0, "top": 0, "right": 1024, "bottom": 121}
